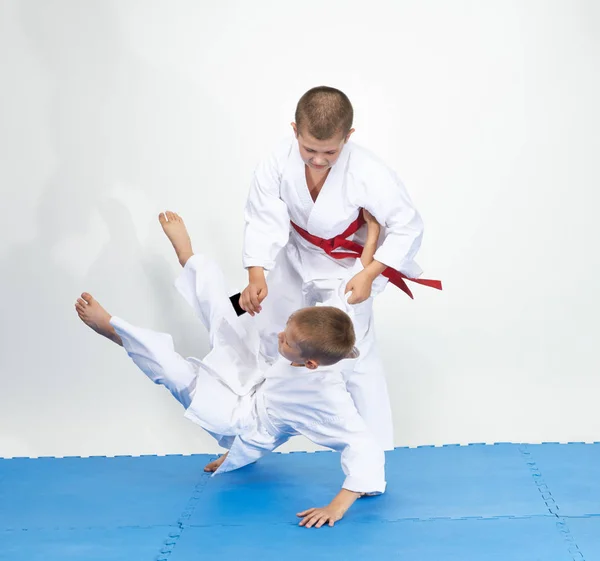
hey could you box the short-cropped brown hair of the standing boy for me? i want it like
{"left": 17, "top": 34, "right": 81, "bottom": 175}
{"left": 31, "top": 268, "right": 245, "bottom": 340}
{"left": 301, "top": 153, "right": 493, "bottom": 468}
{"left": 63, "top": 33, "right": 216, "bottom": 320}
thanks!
{"left": 296, "top": 86, "right": 354, "bottom": 140}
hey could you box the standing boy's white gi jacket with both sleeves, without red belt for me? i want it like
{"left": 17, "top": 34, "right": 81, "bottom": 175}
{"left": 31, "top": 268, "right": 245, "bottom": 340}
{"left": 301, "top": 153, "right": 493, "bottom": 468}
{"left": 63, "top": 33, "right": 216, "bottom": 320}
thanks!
{"left": 243, "top": 138, "right": 423, "bottom": 278}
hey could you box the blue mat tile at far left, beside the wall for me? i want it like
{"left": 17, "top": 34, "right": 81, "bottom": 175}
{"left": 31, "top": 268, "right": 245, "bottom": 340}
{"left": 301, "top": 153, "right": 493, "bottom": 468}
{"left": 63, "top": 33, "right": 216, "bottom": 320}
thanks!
{"left": 0, "top": 455, "right": 211, "bottom": 529}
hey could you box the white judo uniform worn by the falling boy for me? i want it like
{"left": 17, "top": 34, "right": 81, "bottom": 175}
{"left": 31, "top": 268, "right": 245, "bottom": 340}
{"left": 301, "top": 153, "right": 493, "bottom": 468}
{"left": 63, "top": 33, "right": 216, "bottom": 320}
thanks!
{"left": 111, "top": 255, "right": 386, "bottom": 494}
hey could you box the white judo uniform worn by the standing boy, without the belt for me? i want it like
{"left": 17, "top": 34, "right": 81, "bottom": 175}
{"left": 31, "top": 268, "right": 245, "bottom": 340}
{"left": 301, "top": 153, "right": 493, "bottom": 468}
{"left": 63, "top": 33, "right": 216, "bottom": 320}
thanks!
{"left": 243, "top": 138, "right": 423, "bottom": 450}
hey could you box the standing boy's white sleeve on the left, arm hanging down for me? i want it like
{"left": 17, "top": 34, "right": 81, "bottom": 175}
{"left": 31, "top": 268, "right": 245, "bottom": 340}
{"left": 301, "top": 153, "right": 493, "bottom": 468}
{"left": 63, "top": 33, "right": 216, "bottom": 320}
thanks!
{"left": 243, "top": 154, "right": 290, "bottom": 271}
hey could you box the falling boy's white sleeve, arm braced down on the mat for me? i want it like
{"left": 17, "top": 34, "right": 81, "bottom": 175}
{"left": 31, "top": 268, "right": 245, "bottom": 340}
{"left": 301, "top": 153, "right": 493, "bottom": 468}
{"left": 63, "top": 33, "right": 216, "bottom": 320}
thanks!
{"left": 297, "top": 410, "right": 386, "bottom": 495}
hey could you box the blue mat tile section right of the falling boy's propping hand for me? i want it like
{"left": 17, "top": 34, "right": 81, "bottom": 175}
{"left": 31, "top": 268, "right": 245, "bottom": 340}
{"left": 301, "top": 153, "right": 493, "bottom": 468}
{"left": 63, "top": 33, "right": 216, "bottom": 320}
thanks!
{"left": 370, "top": 444, "right": 548, "bottom": 520}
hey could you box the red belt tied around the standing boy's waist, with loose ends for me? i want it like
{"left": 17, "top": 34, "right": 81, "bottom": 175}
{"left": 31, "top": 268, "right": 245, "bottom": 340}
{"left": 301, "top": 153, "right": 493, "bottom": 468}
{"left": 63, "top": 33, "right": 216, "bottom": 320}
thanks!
{"left": 292, "top": 211, "right": 442, "bottom": 298}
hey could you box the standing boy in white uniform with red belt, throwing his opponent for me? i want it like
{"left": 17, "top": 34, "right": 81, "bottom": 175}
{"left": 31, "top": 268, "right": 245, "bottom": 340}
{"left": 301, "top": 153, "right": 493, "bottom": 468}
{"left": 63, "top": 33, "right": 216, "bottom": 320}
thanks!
{"left": 239, "top": 86, "right": 441, "bottom": 450}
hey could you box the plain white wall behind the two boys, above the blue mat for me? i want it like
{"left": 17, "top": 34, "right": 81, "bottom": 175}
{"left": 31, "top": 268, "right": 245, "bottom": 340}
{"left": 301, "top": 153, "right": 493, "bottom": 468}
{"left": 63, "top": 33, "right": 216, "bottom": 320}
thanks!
{"left": 0, "top": 0, "right": 600, "bottom": 456}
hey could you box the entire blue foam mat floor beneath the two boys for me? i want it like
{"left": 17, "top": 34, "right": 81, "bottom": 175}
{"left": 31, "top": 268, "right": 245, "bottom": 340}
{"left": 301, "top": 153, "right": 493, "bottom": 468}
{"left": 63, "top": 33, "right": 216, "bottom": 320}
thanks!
{"left": 0, "top": 444, "right": 600, "bottom": 561}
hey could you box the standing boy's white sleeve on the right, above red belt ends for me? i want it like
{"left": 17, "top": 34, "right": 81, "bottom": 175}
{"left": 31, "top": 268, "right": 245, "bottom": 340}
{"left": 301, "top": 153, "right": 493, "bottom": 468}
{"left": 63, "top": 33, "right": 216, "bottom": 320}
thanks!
{"left": 363, "top": 169, "right": 423, "bottom": 278}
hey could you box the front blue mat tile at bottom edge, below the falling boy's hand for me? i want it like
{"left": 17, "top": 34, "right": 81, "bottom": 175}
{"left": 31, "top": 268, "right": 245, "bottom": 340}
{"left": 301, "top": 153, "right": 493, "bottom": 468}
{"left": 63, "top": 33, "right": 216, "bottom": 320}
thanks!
{"left": 169, "top": 516, "right": 573, "bottom": 561}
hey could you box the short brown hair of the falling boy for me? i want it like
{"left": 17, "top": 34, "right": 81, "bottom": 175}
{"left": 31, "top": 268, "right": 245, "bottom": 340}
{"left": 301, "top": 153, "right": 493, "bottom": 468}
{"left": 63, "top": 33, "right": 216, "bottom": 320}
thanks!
{"left": 289, "top": 306, "right": 359, "bottom": 366}
